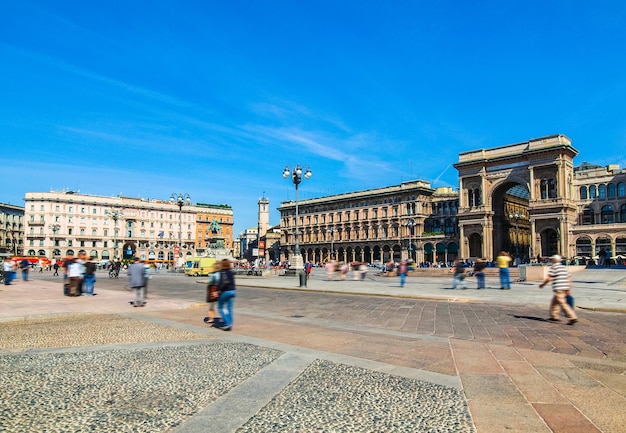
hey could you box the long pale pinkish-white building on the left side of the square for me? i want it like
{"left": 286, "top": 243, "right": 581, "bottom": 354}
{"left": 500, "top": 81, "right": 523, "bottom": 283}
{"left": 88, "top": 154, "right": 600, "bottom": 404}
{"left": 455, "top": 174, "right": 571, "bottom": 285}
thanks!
{"left": 24, "top": 191, "right": 232, "bottom": 263}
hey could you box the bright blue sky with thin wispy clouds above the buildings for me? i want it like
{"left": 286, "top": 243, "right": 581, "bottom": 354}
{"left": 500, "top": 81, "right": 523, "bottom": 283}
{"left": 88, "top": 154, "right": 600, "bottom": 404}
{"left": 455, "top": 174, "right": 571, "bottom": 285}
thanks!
{"left": 0, "top": 0, "right": 626, "bottom": 233}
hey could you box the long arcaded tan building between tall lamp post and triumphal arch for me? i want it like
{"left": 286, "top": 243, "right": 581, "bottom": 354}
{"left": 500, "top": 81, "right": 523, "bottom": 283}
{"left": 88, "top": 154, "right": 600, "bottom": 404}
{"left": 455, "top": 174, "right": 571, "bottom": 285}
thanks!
{"left": 278, "top": 180, "right": 458, "bottom": 263}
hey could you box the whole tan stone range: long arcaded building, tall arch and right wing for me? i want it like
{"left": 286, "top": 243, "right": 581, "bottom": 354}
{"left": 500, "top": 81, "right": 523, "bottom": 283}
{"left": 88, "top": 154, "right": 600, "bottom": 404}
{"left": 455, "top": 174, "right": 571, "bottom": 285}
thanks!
{"left": 279, "top": 134, "right": 626, "bottom": 263}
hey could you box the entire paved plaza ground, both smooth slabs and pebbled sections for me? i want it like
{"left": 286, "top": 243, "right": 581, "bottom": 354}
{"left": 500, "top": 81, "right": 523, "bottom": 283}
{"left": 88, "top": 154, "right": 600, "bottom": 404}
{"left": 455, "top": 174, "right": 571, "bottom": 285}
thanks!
{"left": 0, "top": 269, "right": 626, "bottom": 433}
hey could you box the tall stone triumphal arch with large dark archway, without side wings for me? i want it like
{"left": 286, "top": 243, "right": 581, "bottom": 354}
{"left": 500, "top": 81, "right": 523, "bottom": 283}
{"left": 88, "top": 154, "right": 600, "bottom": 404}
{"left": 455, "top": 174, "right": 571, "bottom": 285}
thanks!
{"left": 454, "top": 134, "right": 578, "bottom": 262}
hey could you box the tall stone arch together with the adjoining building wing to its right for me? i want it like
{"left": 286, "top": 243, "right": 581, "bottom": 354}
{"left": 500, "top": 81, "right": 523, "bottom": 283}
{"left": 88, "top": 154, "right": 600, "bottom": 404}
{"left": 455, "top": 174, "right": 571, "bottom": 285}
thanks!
{"left": 455, "top": 134, "right": 626, "bottom": 261}
